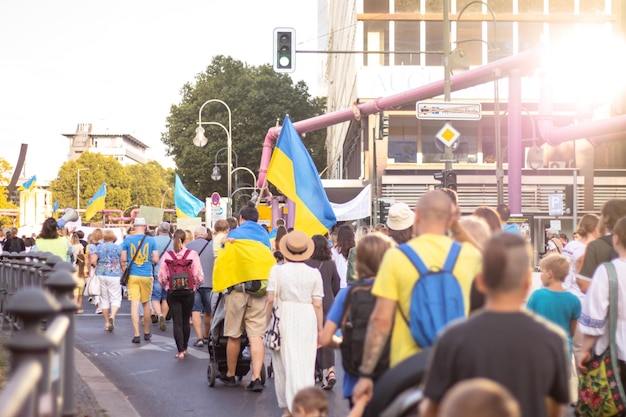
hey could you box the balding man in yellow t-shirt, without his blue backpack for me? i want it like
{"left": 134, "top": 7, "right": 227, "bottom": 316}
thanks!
{"left": 353, "top": 190, "right": 481, "bottom": 402}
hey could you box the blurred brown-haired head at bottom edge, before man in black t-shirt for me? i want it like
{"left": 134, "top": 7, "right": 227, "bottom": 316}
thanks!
{"left": 439, "top": 378, "right": 521, "bottom": 417}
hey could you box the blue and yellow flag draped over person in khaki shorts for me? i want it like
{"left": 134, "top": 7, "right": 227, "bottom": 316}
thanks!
{"left": 213, "top": 222, "right": 276, "bottom": 292}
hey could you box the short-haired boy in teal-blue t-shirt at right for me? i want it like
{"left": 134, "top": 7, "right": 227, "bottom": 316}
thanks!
{"left": 526, "top": 254, "right": 581, "bottom": 355}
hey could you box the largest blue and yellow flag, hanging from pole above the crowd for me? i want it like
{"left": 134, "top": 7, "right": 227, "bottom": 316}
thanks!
{"left": 267, "top": 116, "right": 337, "bottom": 237}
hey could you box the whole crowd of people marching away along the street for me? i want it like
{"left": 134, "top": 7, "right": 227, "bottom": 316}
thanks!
{"left": 2, "top": 193, "right": 626, "bottom": 417}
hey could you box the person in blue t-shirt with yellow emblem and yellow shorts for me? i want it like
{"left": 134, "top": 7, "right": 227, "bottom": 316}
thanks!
{"left": 120, "top": 217, "right": 159, "bottom": 343}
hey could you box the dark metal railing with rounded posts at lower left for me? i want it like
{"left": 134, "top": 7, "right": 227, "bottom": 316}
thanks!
{"left": 0, "top": 252, "right": 77, "bottom": 417}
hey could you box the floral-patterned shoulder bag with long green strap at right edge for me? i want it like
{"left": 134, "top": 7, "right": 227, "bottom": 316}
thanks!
{"left": 576, "top": 262, "right": 626, "bottom": 417}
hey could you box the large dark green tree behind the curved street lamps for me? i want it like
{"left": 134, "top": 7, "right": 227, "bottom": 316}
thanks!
{"left": 161, "top": 55, "right": 326, "bottom": 199}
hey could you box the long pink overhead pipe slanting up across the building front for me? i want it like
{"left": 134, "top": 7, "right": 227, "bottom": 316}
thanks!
{"left": 257, "top": 49, "right": 540, "bottom": 187}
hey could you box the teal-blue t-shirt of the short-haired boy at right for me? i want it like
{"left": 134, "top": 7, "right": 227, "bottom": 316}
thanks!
{"left": 526, "top": 288, "right": 581, "bottom": 354}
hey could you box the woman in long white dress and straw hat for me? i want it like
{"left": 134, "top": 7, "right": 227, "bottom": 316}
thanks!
{"left": 267, "top": 231, "right": 324, "bottom": 417}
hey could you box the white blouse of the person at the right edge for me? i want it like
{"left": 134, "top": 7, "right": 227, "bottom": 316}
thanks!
{"left": 578, "top": 258, "right": 626, "bottom": 360}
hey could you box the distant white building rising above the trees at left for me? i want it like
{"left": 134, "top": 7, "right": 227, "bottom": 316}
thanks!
{"left": 63, "top": 123, "right": 148, "bottom": 166}
